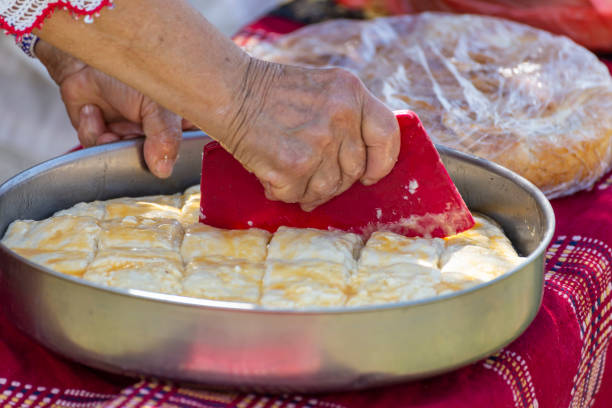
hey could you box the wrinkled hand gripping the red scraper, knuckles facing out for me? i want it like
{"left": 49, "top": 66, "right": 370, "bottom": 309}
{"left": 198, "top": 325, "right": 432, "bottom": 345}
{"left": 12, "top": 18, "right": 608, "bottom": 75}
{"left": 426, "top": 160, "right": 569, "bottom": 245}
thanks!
{"left": 221, "top": 59, "right": 400, "bottom": 211}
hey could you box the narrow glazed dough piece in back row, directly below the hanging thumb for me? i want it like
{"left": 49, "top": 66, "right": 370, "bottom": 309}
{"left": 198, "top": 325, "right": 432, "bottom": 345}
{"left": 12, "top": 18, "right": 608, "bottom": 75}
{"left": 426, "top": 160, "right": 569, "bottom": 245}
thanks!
{"left": 104, "top": 194, "right": 183, "bottom": 220}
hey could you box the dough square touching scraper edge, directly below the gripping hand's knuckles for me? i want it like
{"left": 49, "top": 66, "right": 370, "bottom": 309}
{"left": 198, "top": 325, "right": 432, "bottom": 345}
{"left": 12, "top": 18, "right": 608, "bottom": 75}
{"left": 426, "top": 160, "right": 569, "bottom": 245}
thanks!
{"left": 267, "top": 227, "right": 363, "bottom": 270}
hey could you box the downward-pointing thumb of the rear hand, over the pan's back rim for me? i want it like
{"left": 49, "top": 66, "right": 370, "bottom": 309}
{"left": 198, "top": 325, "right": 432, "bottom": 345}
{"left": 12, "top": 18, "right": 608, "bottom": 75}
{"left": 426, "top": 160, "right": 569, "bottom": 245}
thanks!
{"left": 142, "top": 101, "right": 183, "bottom": 178}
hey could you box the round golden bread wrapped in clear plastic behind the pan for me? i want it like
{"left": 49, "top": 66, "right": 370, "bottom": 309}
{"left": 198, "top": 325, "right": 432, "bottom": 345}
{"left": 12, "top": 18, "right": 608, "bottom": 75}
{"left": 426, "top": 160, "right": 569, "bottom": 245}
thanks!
{"left": 250, "top": 13, "right": 612, "bottom": 198}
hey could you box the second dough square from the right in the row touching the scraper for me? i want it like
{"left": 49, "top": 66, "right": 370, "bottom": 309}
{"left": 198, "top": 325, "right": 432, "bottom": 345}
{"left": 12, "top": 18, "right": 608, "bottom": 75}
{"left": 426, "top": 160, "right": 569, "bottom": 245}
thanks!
{"left": 359, "top": 231, "right": 444, "bottom": 269}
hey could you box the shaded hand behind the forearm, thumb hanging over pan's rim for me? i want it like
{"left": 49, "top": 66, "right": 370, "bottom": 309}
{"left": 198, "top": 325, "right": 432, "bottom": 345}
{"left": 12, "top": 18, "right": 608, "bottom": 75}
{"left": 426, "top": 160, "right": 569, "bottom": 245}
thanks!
{"left": 36, "top": 41, "right": 185, "bottom": 177}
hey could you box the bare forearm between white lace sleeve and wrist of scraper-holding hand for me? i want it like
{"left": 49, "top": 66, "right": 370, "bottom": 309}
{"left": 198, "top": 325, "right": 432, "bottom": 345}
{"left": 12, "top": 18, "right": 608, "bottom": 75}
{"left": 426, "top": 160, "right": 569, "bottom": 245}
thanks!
{"left": 38, "top": 0, "right": 250, "bottom": 141}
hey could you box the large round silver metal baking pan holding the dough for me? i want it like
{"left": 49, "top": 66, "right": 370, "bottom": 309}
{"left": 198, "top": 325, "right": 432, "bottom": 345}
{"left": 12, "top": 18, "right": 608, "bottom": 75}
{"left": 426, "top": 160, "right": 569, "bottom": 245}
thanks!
{"left": 0, "top": 133, "right": 554, "bottom": 392}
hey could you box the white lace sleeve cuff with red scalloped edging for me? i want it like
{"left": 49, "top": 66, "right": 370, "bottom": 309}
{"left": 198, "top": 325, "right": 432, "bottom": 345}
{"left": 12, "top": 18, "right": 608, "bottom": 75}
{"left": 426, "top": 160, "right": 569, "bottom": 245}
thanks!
{"left": 0, "top": 0, "right": 112, "bottom": 35}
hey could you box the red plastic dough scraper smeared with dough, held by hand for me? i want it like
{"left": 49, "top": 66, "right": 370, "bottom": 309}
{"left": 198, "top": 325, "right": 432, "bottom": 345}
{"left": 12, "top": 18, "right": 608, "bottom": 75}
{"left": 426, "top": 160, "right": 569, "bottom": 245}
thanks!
{"left": 200, "top": 111, "right": 474, "bottom": 237}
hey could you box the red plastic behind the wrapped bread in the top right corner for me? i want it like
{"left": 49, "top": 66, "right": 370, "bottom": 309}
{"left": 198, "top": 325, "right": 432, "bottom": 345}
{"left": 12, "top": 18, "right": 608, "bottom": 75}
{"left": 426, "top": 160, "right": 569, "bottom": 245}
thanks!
{"left": 337, "top": 0, "right": 612, "bottom": 52}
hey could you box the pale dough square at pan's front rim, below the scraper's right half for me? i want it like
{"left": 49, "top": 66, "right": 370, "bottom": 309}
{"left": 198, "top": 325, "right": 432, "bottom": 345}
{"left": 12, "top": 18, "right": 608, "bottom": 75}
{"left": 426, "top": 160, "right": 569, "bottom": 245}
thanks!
{"left": 347, "top": 263, "right": 441, "bottom": 306}
